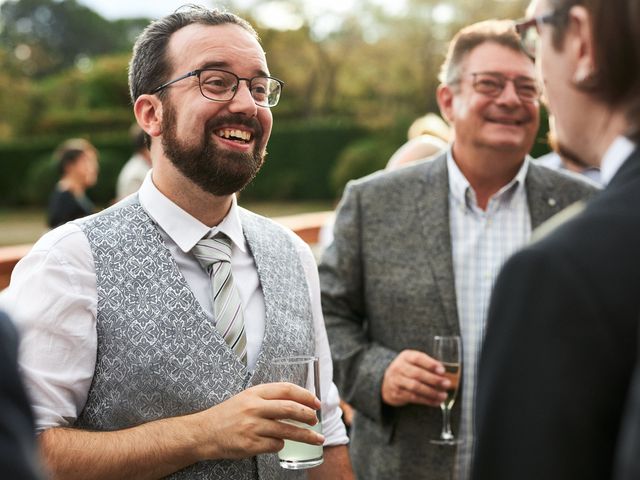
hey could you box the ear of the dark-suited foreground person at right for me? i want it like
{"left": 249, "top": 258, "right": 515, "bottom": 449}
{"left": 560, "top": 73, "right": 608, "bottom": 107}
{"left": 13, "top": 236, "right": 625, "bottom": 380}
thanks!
{"left": 567, "top": 5, "right": 597, "bottom": 86}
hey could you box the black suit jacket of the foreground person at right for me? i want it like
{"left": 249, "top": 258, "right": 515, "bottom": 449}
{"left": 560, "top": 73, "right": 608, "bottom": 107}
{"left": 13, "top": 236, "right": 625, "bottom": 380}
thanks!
{"left": 473, "top": 147, "right": 640, "bottom": 480}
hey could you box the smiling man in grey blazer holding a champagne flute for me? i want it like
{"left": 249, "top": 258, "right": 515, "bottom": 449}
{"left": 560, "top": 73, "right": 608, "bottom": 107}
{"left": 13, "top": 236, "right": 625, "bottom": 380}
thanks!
{"left": 319, "top": 21, "right": 595, "bottom": 480}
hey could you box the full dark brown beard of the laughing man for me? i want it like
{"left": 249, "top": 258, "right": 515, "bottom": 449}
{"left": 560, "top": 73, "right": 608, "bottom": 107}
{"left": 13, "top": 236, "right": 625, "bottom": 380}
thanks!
{"left": 162, "top": 101, "right": 264, "bottom": 196}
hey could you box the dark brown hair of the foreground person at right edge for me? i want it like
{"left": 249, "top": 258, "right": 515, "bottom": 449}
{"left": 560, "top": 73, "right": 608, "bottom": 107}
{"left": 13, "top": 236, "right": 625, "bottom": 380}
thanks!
{"left": 550, "top": 0, "right": 640, "bottom": 141}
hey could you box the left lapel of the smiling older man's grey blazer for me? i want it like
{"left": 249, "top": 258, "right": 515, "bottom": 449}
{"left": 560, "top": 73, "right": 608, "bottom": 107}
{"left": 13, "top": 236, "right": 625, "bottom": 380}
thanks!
{"left": 415, "top": 153, "right": 460, "bottom": 332}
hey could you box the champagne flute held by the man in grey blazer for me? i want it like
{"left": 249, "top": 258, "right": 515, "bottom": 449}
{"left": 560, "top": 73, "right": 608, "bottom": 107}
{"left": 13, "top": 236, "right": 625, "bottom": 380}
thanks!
{"left": 431, "top": 335, "right": 462, "bottom": 445}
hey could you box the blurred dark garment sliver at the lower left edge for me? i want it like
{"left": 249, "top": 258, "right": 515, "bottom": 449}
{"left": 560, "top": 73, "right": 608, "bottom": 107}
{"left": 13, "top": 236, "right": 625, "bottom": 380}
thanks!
{"left": 0, "top": 312, "right": 40, "bottom": 480}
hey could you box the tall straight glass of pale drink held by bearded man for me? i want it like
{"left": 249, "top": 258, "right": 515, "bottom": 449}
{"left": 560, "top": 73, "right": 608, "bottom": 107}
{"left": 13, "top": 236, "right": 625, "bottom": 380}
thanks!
{"left": 273, "top": 356, "right": 323, "bottom": 470}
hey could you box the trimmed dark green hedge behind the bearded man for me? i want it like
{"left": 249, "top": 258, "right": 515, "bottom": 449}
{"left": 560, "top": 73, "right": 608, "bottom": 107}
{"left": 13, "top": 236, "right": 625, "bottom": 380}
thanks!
{"left": 0, "top": 120, "right": 367, "bottom": 206}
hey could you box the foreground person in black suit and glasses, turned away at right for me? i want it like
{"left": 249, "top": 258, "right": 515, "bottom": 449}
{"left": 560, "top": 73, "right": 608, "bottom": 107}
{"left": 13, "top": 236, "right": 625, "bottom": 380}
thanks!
{"left": 473, "top": 0, "right": 640, "bottom": 480}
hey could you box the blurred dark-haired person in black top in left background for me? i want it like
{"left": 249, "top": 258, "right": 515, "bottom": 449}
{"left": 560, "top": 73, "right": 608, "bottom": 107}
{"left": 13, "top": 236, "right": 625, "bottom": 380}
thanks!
{"left": 47, "top": 138, "right": 99, "bottom": 228}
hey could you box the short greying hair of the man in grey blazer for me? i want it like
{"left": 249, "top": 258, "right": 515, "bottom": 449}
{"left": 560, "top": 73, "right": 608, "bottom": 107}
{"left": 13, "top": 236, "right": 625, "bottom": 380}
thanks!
{"left": 438, "top": 20, "right": 533, "bottom": 85}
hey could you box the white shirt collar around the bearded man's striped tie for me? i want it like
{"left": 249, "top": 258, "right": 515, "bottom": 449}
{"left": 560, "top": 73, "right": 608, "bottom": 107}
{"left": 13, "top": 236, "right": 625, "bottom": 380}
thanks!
{"left": 138, "top": 171, "right": 247, "bottom": 253}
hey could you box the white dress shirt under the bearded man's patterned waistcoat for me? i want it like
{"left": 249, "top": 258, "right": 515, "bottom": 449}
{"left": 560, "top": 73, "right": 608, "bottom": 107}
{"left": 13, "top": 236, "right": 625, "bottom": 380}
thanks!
{"left": 1, "top": 173, "right": 348, "bottom": 445}
